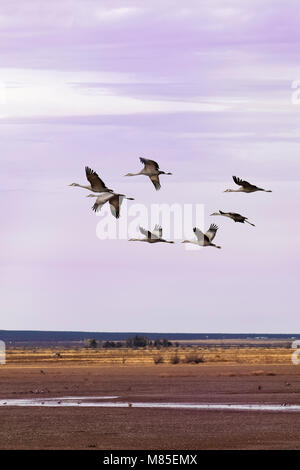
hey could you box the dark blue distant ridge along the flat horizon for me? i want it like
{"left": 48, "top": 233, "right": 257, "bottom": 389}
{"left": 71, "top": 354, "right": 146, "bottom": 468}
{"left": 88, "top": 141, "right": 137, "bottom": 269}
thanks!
{"left": 0, "top": 330, "right": 300, "bottom": 342}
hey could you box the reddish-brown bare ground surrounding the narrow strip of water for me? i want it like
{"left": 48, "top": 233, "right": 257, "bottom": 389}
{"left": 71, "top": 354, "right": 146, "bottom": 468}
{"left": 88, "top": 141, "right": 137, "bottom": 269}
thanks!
{"left": 0, "top": 364, "right": 300, "bottom": 450}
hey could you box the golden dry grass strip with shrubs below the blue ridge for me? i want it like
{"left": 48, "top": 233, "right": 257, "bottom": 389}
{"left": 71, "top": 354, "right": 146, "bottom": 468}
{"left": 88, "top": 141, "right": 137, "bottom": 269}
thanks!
{"left": 6, "top": 343, "right": 292, "bottom": 366}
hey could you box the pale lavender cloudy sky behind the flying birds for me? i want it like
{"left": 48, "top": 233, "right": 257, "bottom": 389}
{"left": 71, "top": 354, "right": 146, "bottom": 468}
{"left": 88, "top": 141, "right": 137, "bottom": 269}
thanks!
{"left": 0, "top": 0, "right": 300, "bottom": 333}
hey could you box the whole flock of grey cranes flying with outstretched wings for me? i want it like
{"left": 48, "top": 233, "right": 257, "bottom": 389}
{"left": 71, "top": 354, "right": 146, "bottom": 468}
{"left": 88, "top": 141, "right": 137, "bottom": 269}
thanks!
{"left": 70, "top": 158, "right": 272, "bottom": 248}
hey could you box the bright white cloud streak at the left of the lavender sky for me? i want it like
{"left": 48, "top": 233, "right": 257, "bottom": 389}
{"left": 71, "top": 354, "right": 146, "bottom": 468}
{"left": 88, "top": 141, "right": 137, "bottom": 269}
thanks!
{"left": 2, "top": 70, "right": 229, "bottom": 118}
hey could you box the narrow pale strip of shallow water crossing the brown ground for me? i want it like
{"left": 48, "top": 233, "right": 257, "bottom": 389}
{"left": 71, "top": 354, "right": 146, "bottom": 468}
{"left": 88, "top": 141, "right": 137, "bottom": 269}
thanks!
{"left": 0, "top": 396, "right": 300, "bottom": 412}
